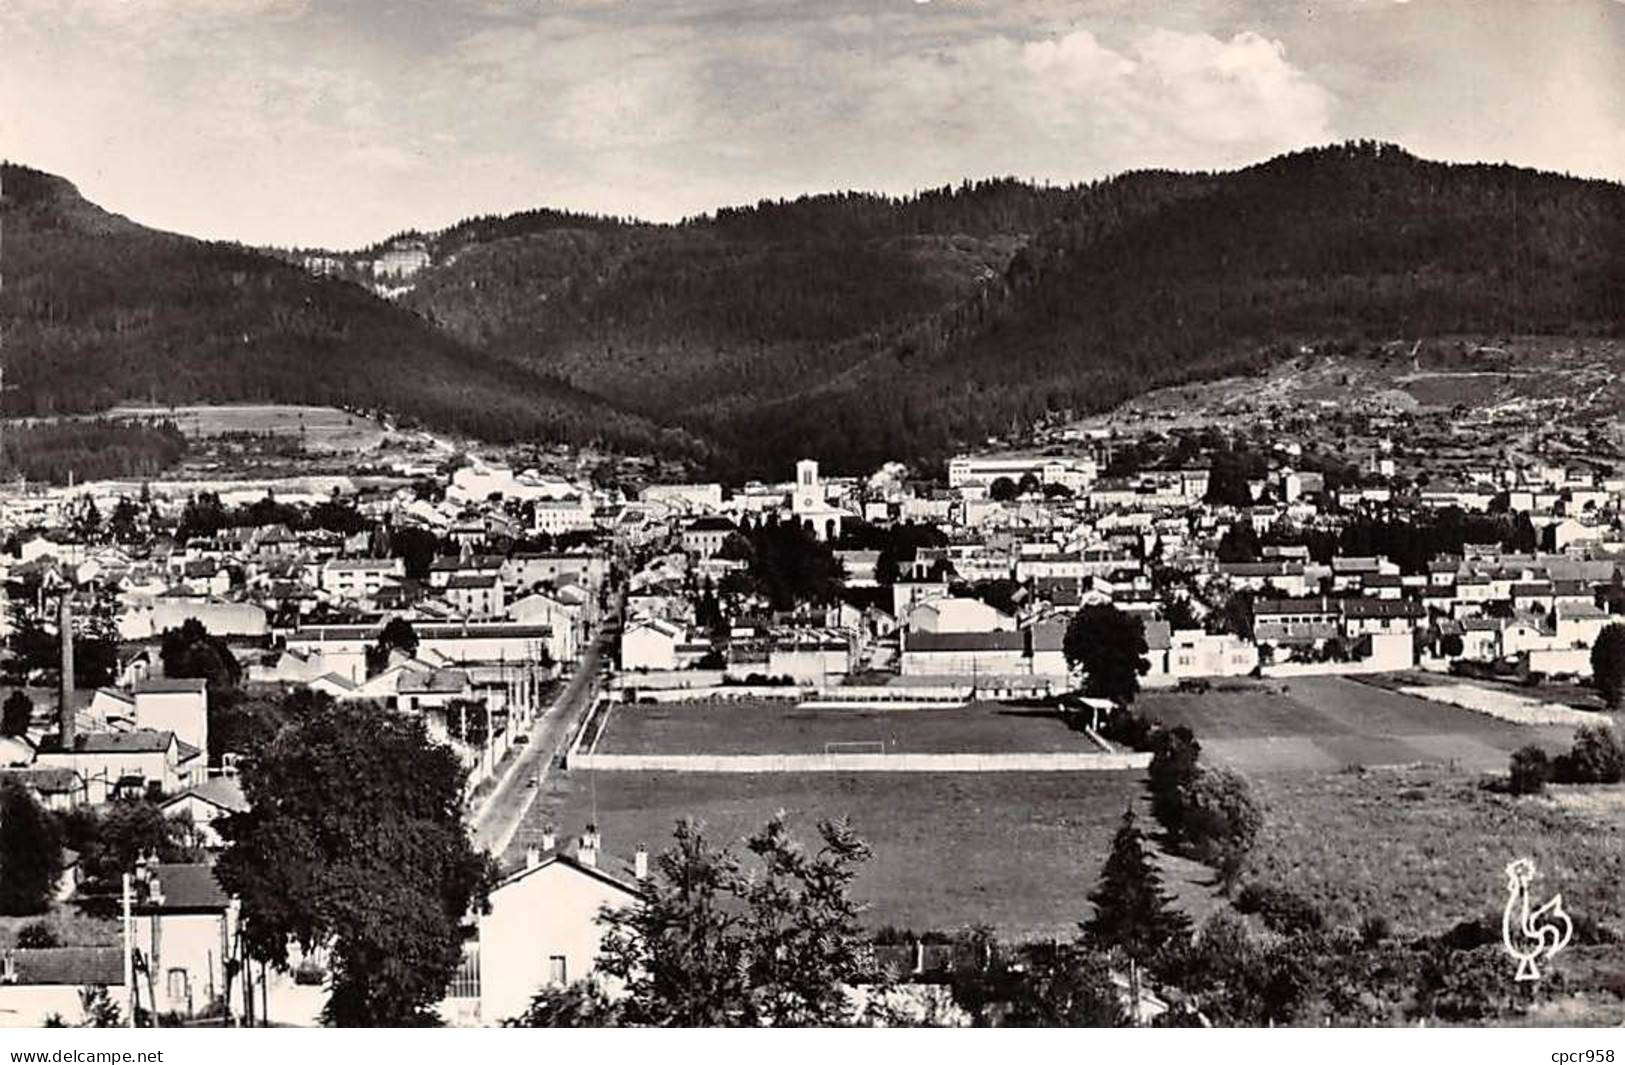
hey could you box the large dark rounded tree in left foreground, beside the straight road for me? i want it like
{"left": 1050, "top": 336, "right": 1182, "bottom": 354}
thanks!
{"left": 216, "top": 696, "right": 494, "bottom": 1026}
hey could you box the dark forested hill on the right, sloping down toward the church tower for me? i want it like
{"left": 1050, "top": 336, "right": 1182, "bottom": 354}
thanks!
{"left": 696, "top": 143, "right": 1625, "bottom": 470}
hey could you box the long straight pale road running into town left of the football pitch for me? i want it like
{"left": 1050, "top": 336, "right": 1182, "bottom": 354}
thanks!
{"left": 468, "top": 600, "right": 621, "bottom": 862}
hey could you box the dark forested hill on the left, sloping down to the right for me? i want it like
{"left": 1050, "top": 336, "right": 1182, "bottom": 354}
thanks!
{"left": 0, "top": 164, "right": 694, "bottom": 450}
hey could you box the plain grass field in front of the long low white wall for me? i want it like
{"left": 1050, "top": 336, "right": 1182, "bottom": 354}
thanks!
{"left": 505, "top": 771, "right": 1214, "bottom": 940}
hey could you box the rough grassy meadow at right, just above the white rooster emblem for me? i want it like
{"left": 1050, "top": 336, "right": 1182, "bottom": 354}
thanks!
{"left": 1253, "top": 767, "right": 1625, "bottom": 933}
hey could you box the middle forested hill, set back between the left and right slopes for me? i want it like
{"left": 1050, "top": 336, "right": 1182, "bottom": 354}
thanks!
{"left": 401, "top": 180, "right": 1077, "bottom": 423}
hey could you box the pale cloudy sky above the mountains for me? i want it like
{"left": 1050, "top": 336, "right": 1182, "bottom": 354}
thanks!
{"left": 0, "top": 0, "right": 1625, "bottom": 247}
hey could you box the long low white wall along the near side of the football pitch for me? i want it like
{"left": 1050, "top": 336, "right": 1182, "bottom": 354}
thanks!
{"left": 570, "top": 751, "right": 1151, "bottom": 772}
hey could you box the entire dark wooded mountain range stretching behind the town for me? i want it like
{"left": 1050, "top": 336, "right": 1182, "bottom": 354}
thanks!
{"left": 7, "top": 141, "right": 1625, "bottom": 478}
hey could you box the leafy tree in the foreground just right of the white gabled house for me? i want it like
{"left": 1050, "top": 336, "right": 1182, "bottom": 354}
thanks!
{"left": 598, "top": 816, "right": 871, "bottom": 1028}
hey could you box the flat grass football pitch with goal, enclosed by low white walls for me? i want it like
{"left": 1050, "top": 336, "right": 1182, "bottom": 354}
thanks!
{"left": 593, "top": 699, "right": 1100, "bottom": 754}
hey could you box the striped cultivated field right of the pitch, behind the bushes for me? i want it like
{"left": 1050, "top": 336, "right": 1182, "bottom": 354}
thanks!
{"left": 1136, "top": 676, "right": 1573, "bottom": 772}
